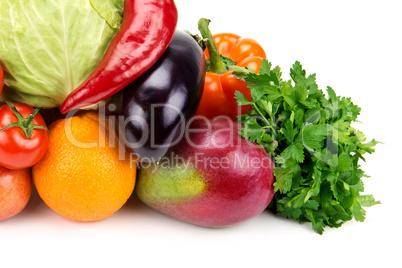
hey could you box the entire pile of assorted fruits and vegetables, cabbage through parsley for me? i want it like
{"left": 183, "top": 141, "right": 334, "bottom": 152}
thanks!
{"left": 0, "top": 0, "right": 379, "bottom": 234}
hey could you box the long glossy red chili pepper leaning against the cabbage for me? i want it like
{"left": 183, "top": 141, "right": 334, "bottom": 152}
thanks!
{"left": 60, "top": 0, "right": 178, "bottom": 114}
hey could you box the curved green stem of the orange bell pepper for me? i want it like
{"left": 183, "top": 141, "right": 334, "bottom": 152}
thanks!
{"left": 198, "top": 18, "right": 227, "bottom": 74}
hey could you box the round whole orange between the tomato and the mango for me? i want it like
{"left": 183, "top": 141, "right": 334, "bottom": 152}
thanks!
{"left": 32, "top": 112, "right": 136, "bottom": 221}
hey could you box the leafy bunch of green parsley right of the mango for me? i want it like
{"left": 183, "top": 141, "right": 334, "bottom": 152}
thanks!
{"left": 234, "top": 59, "right": 380, "bottom": 234}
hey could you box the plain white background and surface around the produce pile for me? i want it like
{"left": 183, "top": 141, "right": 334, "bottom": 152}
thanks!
{"left": 0, "top": 0, "right": 402, "bottom": 267}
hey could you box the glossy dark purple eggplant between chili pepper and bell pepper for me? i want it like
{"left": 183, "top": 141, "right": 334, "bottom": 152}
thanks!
{"left": 114, "top": 31, "right": 206, "bottom": 162}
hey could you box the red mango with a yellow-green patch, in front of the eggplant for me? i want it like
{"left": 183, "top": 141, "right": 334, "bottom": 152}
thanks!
{"left": 135, "top": 119, "right": 274, "bottom": 227}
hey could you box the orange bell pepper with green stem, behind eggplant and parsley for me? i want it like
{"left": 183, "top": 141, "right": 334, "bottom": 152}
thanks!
{"left": 196, "top": 19, "right": 266, "bottom": 121}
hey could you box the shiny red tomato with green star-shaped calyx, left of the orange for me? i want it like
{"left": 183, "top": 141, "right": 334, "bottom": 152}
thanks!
{"left": 0, "top": 103, "right": 48, "bottom": 169}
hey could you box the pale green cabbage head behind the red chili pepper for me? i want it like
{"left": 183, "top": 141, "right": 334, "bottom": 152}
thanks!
{"left": 0, "top": 0, "right": 124, "bottom": 108}
